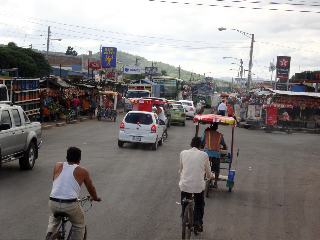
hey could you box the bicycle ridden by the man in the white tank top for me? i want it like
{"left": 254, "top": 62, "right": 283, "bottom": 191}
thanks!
{"left": 48, "top": 196, "right": 92, "bottom": 240}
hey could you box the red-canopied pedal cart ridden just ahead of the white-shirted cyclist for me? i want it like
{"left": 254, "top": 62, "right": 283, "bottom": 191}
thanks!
{"left": 193, "top": 114, "right": 239, "bottom": 193}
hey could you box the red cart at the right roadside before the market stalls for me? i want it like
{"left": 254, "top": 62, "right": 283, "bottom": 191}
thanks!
{"left": 263, "top": 104, "right": 293, "bottom": 134}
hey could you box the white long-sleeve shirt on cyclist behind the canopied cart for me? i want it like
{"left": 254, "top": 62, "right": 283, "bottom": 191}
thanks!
{"left": 179, "top": 147, "right": 212, "bottom": 193}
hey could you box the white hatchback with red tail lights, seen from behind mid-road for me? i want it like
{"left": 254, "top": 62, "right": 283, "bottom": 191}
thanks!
{"left": 118, "top": 111, "right": 164, "bottom": 150}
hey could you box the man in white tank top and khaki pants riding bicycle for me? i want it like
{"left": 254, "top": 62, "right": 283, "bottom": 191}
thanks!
{"left": 46, "top": 147, "right": 101, "bottom": 239}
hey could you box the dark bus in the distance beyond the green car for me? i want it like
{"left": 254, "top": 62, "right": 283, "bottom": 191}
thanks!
{"left": 152, "top": 76, "right": 182, "bottom": 100}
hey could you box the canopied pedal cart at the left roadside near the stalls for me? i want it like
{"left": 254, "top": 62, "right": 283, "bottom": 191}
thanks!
{"left": 97, "top": 91, "right": 118, "bottom": 122}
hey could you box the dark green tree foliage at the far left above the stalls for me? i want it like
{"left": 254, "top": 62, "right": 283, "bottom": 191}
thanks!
{"left": 0, "top": 42, "right": 51, "bottom": 77}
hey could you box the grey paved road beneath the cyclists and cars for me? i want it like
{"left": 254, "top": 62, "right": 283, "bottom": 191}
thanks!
{"left": 0, "top": 108, "right": 320, "bottom": 239}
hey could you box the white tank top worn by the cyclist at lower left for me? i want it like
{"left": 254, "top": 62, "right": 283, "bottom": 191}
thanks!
{"left": 50, "top": 162, "right": 80, "bottom": 199}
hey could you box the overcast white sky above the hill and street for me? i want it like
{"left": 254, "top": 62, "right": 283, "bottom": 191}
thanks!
{"left": 0, "top": 0, "right": 320, "bottom": 79}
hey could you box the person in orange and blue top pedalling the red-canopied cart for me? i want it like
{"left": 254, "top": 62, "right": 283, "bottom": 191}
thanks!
{"left": 201, "top": 122, "right": 228, "bottom": 188}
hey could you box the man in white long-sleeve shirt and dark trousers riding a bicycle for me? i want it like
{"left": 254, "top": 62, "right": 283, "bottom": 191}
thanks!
{"left": 179, "top": 137, "right": 214, "bottom": 232}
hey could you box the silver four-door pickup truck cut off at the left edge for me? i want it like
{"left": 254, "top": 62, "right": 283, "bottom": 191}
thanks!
{"left": 0, "top": 103, "right": 42, "bottom": 170}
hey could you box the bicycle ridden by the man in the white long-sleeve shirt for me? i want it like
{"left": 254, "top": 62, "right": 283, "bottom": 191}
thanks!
{"left": 182, "top": 194, "right": 198, "bottom": 239}
